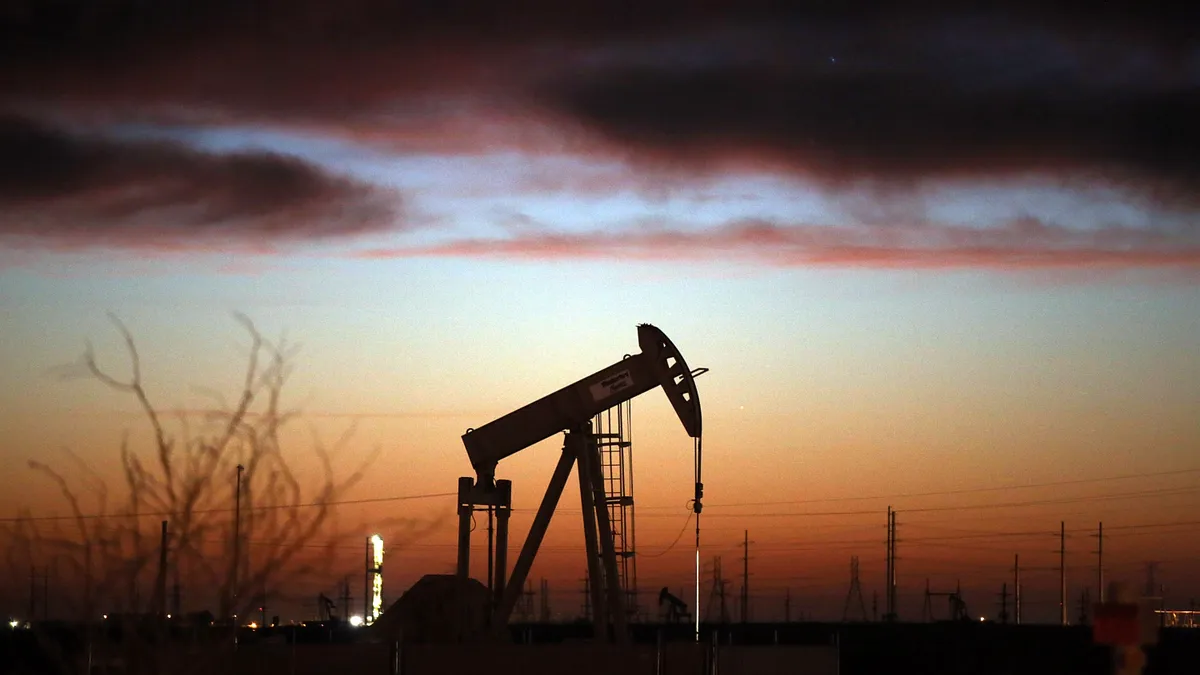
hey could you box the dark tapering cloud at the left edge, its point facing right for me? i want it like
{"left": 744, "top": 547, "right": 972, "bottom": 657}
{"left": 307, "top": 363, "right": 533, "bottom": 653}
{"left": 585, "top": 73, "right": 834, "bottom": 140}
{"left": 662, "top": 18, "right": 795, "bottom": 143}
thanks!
{"left": 0, "top": 117, "right": 396, "bottom": 250}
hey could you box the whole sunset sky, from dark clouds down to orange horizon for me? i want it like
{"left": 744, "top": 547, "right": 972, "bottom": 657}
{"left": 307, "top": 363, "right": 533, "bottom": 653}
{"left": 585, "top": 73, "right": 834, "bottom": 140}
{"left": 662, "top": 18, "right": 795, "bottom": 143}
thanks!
{"left": 0, "top": 0, "right": 1200, "bottom": 621}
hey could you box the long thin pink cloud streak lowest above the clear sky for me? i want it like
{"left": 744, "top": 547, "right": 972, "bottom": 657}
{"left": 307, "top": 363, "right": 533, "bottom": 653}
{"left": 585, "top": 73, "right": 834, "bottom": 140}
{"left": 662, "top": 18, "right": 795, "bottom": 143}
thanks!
{"left": 352, "top": 219, "right": 1200, "bottom": 275}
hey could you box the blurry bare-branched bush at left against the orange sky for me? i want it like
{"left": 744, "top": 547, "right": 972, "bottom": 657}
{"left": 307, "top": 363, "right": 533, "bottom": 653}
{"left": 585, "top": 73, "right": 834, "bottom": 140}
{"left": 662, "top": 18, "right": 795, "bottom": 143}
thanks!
{"left": 6, "top": 315, "right": 403, "bottom": 671}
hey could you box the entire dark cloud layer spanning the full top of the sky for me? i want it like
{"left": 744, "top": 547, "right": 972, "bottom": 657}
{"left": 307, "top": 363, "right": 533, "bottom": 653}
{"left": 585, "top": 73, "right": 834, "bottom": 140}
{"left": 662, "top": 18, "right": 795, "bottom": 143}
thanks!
{"left": 0, "top": 0, "right": 1200, "bottom": 214}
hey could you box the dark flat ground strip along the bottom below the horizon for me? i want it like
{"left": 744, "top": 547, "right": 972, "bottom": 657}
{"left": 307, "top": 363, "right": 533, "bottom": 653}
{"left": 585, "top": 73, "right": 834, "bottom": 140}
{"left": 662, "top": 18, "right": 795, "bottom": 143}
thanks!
{"left": 0, "top": 623, "right": 1200, "bottom": 675}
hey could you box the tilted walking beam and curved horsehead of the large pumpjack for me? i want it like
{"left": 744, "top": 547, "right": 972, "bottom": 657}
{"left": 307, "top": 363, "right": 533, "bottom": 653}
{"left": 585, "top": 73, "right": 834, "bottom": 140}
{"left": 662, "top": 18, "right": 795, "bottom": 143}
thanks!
{"left": 462, "top": 323, "right": 703, "bottom": 491}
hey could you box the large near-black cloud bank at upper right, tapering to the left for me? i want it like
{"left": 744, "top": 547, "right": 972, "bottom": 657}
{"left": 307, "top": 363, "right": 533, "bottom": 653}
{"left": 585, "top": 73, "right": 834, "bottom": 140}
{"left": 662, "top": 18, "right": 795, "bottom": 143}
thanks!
{"left": 541, "top": 17, "right": 1200, "bottom": 208}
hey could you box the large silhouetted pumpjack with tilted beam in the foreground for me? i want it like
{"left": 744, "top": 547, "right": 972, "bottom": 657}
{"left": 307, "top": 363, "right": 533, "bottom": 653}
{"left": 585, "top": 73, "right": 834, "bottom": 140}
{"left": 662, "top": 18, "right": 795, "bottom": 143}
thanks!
{"left": 456, "top": 323, "right": 708, "bottom": 643}
